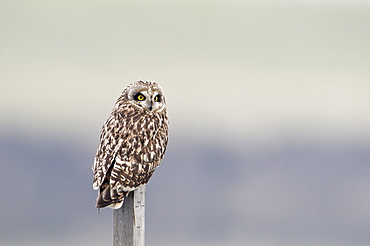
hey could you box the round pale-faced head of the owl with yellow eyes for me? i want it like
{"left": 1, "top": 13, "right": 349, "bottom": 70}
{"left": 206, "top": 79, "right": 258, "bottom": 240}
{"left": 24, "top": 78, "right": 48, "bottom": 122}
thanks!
{"left": 122, "top": 81, "right": 166, "bottom": 113}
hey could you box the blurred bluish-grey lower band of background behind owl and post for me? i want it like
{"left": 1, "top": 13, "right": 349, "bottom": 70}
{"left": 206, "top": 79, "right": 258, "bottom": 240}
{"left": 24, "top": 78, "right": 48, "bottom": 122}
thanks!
{"left": 0, "top": 125, "right": 370, "bottom": 245}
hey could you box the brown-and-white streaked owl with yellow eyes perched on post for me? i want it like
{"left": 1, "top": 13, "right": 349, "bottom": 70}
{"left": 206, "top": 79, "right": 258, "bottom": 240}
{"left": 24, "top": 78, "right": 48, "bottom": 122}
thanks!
{"left": 92, "top": 81, "right": 168, "bottom": 209}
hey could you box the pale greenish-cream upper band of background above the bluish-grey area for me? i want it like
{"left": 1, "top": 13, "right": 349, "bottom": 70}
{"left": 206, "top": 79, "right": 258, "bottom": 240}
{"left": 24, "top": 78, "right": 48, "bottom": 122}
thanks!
{"left": 0, "top": 1, "right": 370, "bottom": 140}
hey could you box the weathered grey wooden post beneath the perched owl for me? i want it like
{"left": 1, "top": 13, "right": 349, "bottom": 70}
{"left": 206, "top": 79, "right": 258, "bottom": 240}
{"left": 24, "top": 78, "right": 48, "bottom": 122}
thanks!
{"left": 113, "top": 185, "right": 145, "bottom": 246}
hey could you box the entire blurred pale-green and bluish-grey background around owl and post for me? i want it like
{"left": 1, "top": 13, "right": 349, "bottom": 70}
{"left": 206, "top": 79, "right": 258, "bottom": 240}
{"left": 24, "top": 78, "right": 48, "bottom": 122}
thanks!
{"left": 0, "top": 0, "right": 370, "bottom": 246}
